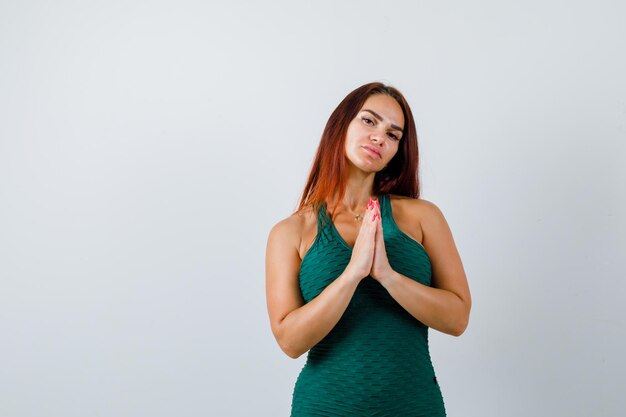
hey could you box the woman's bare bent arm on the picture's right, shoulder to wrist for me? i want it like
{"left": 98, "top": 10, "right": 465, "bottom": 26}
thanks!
{"left": 379, "top": 200, "right": 472, "bottom": 336}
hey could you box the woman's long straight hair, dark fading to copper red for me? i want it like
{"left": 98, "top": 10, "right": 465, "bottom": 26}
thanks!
{"left": 296, "top": 82, "right": 420, "bottom": 218}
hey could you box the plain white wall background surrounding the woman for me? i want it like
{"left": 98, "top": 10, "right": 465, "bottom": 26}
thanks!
{"left": 0, "top": 0, "right": 626, "bottom": 417}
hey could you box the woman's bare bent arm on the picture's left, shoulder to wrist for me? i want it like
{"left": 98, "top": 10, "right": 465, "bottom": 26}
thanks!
{"left": 265, "top": 216, "right": 360, "bottom": 359}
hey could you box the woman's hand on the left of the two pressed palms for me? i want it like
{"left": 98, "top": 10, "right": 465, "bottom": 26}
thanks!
{"left": 346, "top": 200, "right": 380, "bottom": 281}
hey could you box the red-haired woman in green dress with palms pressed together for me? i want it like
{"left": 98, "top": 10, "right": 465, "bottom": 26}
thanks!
{"left": 266, "top": 83, "right": 471, "bottom": 417}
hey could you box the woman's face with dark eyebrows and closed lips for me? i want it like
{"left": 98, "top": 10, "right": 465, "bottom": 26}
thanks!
{"left": 345, "top": 94, "right": 404, "bottom": 172}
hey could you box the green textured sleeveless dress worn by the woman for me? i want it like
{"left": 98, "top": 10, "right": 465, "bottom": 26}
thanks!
{"left": 291, "top": 195, "right": 446, "bottom": 417}
